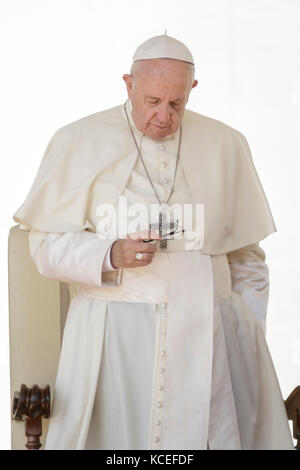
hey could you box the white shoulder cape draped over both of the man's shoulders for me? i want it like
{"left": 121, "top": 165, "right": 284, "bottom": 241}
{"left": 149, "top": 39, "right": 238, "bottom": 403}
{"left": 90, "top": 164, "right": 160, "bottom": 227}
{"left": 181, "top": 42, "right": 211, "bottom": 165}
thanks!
{"left": 13, "top": 105, "right": 276, "bottom": 255}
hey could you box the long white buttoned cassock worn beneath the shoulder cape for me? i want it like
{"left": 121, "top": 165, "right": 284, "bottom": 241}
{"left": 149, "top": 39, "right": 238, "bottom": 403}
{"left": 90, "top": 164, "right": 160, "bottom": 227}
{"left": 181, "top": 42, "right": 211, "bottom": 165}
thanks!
{"left": 15, "top": 98, "right": 293, "bottom": 450}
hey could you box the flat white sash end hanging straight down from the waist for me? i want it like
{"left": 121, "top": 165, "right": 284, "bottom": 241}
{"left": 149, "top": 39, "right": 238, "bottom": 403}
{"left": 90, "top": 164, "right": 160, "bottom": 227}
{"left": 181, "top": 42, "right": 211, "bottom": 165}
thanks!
{"left": 159, "top": 251, "right": 213, "bottom": 449}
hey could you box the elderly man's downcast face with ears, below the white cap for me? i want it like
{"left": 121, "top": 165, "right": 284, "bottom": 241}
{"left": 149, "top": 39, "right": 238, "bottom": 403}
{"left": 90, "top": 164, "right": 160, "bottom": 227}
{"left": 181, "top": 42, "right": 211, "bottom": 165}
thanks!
{"left": 123, "top": 59, "right": 197, "bottom": 140}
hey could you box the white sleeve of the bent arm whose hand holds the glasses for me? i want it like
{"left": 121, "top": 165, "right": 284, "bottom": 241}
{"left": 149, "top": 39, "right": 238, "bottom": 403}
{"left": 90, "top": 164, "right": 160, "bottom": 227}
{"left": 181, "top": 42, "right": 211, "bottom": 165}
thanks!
{"left": 28, "top": 229, "right": 121, "bottom": 287}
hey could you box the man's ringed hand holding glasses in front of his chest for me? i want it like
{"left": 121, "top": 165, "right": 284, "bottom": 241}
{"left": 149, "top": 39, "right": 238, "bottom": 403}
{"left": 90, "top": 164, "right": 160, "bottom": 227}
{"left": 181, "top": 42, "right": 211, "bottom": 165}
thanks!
{"left": 110, "top": 230, "right": 161, "bottom": 269}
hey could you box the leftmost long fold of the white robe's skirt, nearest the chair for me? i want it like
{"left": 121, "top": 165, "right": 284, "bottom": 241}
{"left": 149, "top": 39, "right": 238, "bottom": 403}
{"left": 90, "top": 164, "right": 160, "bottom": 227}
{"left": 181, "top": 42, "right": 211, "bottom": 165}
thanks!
{"left": 45, "top": 296, "right": 107, "bottom": 450}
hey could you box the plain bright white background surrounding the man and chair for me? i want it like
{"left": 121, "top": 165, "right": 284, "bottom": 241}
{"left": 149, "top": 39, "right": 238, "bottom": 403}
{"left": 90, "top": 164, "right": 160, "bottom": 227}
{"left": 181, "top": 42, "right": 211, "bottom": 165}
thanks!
{"left": 0, "top": 0, "right": 300, "bottom": 449}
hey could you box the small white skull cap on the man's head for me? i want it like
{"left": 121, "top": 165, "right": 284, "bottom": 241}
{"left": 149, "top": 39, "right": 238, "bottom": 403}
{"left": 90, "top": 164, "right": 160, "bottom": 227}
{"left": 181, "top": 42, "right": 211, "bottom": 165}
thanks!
{"left": 133, "top": 34, "right": 194, "bottom": 64}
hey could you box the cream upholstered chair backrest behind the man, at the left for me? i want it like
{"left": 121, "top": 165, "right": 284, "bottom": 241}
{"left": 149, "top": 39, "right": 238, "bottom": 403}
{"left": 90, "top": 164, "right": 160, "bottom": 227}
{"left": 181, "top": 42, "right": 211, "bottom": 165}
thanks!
{"left": 8, "top": 225, "right": 70, "bottom": 450}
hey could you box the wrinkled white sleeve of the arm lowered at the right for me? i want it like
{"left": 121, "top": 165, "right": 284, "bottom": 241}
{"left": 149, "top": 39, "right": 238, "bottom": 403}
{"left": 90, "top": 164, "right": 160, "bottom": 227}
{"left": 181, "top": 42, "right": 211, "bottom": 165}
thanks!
{"left": 227, "top": 243, "right": 269, "bottom": 333}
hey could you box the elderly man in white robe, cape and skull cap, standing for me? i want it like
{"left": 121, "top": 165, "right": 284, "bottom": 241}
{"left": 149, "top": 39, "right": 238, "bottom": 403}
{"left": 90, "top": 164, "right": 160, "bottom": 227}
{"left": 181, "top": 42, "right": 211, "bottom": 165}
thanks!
{"left": 14, "top": 36, "right": 293, "bottom": 450}
